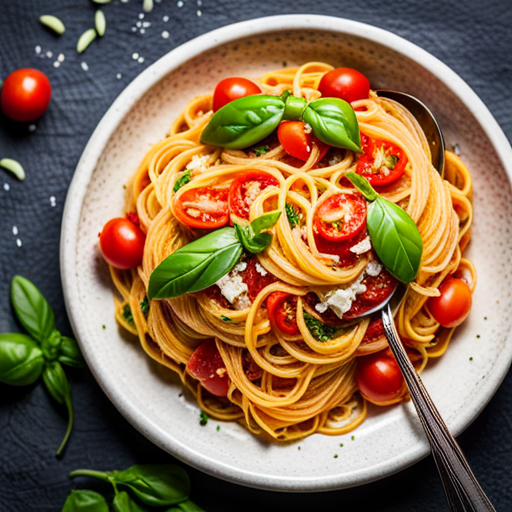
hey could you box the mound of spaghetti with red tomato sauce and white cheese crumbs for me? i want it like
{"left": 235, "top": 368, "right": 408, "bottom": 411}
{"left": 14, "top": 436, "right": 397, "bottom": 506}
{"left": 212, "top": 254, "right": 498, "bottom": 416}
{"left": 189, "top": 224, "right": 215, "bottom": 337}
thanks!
{"left": 105, "top": 62, "right": 476, "bottom": 441}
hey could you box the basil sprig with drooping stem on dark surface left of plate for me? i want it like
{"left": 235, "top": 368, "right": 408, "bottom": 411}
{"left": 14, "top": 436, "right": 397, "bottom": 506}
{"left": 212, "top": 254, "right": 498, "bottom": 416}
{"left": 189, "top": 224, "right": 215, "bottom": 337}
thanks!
{"left": 0, "top": 276, "right": 84, "bottom": 455}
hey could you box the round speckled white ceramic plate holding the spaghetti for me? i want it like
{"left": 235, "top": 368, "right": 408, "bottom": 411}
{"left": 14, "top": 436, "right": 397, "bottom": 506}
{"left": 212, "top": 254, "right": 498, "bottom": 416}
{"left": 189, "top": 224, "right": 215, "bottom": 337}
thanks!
{"left": 61, "top": 15, "right": 512, "bottom": 491}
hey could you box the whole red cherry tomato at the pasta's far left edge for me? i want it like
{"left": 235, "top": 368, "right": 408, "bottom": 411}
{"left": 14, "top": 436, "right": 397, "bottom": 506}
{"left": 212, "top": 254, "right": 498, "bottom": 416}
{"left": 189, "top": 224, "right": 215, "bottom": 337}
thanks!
{"left": 100, "top": 217, "right": 146, "bottom": 270}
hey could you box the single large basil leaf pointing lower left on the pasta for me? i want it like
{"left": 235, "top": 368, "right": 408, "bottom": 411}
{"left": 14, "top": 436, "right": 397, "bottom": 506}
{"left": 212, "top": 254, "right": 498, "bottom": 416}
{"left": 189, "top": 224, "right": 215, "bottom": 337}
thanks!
{"left": 148, "top": 228, "right": 242, "bottom": 300}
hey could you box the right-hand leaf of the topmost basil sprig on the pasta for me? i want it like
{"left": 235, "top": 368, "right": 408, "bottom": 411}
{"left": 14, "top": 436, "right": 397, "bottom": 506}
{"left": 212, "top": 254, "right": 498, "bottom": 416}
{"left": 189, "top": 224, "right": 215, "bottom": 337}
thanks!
{"left": 302, "top": 98, "right": 361, "bottom": 152}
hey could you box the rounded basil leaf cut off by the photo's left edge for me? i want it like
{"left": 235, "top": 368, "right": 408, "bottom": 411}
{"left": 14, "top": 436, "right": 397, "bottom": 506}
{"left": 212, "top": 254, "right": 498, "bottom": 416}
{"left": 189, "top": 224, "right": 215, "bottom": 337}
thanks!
{"left": 0, "top": 333, "right": 45, "bottom": 386}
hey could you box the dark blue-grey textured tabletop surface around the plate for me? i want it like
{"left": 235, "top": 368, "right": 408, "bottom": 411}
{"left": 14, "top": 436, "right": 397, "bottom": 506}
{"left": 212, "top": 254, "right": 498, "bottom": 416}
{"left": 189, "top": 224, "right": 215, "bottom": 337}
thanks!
{"left": 0, "top": 0, "right": 512, "bottom": 512}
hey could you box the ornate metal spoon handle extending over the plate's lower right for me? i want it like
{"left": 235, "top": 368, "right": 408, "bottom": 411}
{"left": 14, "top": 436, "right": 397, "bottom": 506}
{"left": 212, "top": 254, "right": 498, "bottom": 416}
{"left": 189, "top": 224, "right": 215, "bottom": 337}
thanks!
{"left": 382, "top": 305, "right": 495, "bottom": 512}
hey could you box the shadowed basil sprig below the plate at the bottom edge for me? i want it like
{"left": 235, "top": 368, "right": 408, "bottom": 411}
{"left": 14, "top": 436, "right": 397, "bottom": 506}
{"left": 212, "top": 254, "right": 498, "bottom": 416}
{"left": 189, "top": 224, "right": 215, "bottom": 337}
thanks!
{"left": 63, "top": 464, "right": 204, "bottom": 512}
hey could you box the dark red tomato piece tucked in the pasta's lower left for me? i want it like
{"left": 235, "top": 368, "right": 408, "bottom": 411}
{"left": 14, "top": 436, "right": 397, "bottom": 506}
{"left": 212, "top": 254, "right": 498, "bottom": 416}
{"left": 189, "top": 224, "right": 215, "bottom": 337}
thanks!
{"left": 186, "top": 340, "right": 230, "bottom": 396}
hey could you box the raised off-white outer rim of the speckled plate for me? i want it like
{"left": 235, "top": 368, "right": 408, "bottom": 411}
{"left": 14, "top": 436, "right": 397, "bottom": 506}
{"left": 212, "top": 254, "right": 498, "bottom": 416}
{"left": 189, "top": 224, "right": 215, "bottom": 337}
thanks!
{"left": 60, "top": 14, "right": 512, "bottom": 492}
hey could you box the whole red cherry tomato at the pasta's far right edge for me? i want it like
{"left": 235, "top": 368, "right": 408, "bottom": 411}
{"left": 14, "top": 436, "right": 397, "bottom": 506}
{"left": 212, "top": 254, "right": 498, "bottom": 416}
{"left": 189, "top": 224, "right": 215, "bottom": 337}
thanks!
{"left": 427, "top": 277, "right": 472, "bottom": 327}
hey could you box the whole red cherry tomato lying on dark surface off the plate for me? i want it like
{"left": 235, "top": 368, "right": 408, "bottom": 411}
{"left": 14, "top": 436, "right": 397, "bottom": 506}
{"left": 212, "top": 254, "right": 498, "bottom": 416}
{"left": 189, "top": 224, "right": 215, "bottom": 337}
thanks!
{"left": 0, "top": 68, "right": 52, "bottom": 121}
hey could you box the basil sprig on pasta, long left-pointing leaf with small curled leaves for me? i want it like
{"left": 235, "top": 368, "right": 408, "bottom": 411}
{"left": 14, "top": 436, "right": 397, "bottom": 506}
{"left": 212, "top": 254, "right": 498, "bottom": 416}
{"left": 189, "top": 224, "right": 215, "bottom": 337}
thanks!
{"left": 148, "top": 210, "right": 281, "bottom": 300}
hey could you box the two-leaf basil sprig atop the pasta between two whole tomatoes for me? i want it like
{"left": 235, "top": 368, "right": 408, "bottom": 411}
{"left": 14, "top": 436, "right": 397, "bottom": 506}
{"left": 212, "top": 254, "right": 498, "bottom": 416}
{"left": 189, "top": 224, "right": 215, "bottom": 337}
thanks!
{"left": 201, "top": 91, "right": 361, "bottom": 151}
